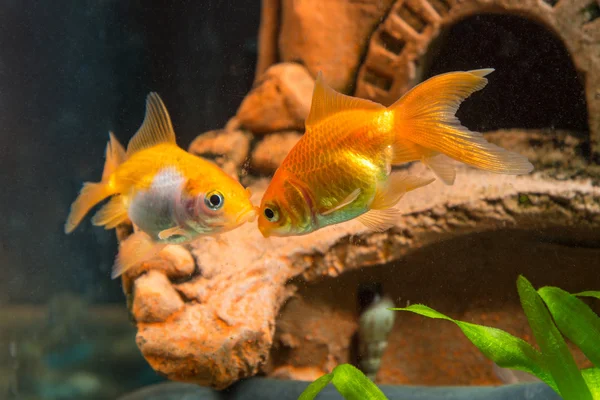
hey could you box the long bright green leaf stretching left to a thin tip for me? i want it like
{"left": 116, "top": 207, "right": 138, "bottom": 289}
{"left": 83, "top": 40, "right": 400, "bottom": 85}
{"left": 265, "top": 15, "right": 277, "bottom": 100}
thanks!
{"left": 391, "top": 304, "right": 558, "bottom": 392}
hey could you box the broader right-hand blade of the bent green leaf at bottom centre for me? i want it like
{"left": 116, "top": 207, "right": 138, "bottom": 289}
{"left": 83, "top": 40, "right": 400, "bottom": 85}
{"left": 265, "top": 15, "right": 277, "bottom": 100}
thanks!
{"left": 332, "top": 364, "right": 387, "bottom": 400}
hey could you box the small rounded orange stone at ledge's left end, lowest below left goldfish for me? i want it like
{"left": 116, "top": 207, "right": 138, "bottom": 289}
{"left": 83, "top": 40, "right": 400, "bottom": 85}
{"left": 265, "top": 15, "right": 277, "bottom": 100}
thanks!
{"left": 132, "top": 270, "right": 183, "bottom": 322}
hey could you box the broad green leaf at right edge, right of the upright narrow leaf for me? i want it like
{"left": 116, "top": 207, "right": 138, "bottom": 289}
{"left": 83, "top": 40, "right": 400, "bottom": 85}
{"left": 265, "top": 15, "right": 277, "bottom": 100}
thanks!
{"left": 538, "top": 286, "right": 600, "bottom": 367}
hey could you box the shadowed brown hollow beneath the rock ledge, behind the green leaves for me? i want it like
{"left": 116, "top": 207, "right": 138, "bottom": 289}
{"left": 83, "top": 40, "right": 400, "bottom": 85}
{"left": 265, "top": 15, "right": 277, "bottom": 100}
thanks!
{"left": 268, "top": 227, "right": 600, "bottom": 386}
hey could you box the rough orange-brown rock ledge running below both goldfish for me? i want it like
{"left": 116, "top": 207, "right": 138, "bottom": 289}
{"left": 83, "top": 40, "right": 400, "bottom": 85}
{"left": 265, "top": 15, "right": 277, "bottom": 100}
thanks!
{"left": 120, "top": 165, "right": 600, "bottom": 389}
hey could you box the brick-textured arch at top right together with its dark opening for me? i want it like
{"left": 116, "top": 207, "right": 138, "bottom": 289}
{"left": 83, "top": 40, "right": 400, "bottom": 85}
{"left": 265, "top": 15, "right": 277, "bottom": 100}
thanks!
{"left": 353, "top": 0, "right": 600, "bottom": 159}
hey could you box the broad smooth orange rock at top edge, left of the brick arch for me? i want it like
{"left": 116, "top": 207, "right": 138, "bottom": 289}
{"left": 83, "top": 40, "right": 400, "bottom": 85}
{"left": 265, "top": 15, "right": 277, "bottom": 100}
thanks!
{"left": 276, "top": 0, "right": 393, "bottom": 92}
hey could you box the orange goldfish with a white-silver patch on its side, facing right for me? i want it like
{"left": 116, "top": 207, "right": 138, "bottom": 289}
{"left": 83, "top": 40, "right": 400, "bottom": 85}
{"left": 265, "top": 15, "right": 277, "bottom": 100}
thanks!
{"left": 65, "top": 93, "right": 256, "bottom": 279}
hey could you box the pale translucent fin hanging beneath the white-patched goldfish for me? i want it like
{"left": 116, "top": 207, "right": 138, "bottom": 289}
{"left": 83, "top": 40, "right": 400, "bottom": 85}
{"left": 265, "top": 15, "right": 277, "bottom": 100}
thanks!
{"left": 111, "top": 231, "right": 166, "bottom": 279}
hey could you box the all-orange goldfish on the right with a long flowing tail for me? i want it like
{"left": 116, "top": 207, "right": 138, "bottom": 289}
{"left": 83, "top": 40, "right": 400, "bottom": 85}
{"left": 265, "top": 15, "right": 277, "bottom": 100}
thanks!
{"left": 258, "top": 69, "right": 533, "bottom": 237}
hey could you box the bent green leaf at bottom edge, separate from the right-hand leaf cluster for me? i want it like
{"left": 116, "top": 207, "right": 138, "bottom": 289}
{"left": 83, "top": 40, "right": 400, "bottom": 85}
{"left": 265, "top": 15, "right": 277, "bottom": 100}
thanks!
{"left": 298, "top": 364, "right": 387, "bottom": 400}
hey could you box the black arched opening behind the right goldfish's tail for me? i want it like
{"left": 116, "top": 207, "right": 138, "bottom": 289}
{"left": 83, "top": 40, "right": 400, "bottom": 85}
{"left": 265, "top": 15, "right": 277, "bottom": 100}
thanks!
{"left": 423, "top": 14, "right": 588, "bottom": 137}
